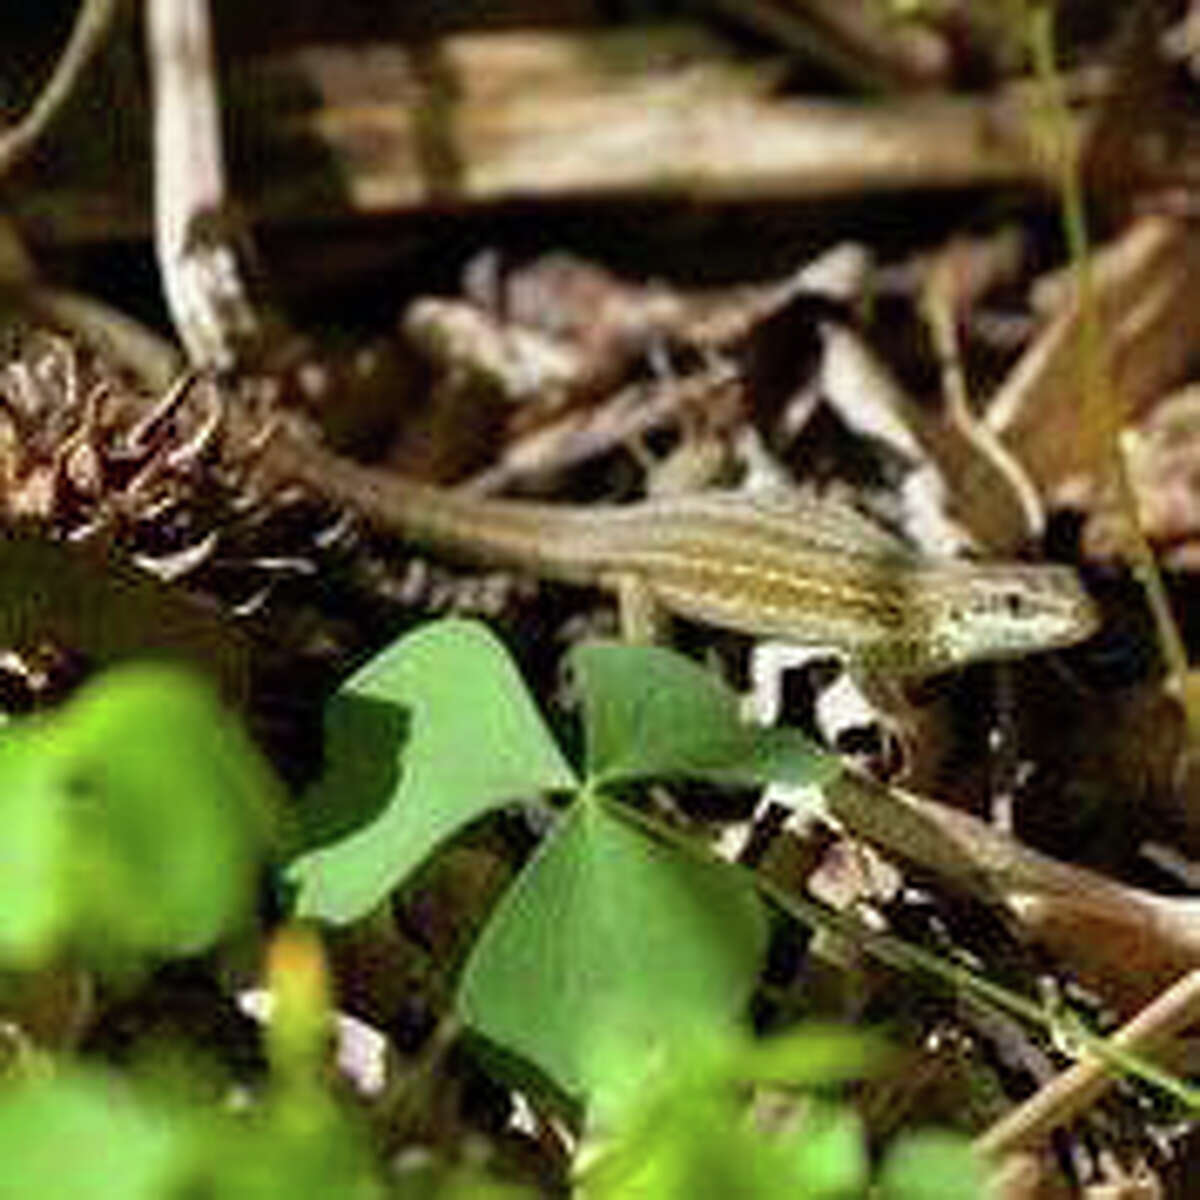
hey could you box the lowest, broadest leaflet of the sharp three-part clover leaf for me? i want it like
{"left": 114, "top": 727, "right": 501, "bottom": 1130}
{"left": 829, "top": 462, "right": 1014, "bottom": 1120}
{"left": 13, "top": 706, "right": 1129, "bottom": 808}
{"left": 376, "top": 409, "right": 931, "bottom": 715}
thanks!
{"left": 458, "top": 797, "right": 766, "bottom": 1100}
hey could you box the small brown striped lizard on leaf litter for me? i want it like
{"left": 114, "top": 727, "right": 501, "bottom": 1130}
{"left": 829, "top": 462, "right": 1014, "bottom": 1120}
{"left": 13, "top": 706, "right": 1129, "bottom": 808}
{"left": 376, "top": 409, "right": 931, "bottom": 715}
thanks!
{"left": 250, "top": 414, "right": 1099, "bottom": 676}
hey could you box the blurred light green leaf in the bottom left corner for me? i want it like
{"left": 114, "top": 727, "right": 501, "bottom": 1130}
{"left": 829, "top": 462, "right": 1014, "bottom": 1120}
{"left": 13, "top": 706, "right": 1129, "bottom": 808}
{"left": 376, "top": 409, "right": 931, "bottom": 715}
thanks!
{"left": 0, "top": 1073, "right": 180, "bottom": 1200}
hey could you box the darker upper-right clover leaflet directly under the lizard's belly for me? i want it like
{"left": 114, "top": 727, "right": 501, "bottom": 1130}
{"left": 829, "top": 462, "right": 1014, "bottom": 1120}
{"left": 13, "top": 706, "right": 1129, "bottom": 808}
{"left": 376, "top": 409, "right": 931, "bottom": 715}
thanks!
{"left": 571, "top": 642, "right": 838, "bottom": 784}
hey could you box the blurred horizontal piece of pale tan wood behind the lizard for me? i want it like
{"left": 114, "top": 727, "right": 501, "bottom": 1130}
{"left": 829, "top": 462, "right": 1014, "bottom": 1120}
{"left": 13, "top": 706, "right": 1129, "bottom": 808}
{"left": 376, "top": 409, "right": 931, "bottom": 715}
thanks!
{"left": 11, "top": 25, "right": 1049, "bottom": 244}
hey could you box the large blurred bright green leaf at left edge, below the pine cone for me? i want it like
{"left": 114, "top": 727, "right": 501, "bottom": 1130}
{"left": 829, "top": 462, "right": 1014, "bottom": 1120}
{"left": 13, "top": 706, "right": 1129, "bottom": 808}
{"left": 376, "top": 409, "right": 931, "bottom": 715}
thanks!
{"left": 0, "top": 665, "right": 274, "bottom": 966}
